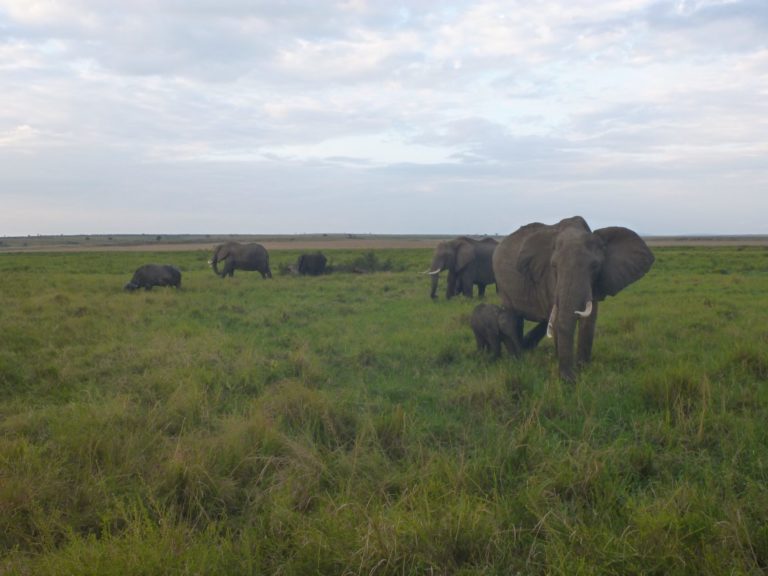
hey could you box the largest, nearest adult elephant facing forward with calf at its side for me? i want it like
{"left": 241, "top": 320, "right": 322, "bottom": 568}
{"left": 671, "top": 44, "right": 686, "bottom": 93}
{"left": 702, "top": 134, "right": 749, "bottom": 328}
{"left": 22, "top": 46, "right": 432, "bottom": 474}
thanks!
{"left": 493, "top": 216, "right": 654, "bottom": 380}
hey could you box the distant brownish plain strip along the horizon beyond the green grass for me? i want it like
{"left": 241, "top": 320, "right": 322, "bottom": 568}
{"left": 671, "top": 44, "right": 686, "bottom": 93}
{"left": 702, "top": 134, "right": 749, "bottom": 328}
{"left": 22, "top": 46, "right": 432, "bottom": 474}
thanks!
{"left": 0, "top": 234, "right": 768, "bottom": 253}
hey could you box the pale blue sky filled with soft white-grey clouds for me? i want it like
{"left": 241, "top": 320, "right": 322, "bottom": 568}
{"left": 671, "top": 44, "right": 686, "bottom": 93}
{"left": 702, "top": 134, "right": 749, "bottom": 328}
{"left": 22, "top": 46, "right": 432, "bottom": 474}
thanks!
{"left": 0, "top": 0, "right": 768, "bottom": 236}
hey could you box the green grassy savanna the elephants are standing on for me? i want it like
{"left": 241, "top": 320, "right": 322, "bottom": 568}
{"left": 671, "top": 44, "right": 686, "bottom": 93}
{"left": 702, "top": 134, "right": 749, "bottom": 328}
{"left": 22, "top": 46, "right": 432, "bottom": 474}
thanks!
{"left": 0, "top": 247, "right": 768, "bottom": 575}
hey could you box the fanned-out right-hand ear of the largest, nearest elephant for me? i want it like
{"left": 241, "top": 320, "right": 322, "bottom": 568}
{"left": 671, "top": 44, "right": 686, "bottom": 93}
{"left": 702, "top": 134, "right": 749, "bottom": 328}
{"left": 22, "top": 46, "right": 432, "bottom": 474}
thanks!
{"left": 594, "top": 226, "right": 654, "bottom": 300}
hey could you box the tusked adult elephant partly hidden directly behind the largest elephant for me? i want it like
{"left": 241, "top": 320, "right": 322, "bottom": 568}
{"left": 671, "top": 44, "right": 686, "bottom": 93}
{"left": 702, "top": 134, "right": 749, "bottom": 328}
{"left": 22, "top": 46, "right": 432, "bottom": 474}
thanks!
{"left": 427, "top": 236, "right": 498, "bottom": 298}
